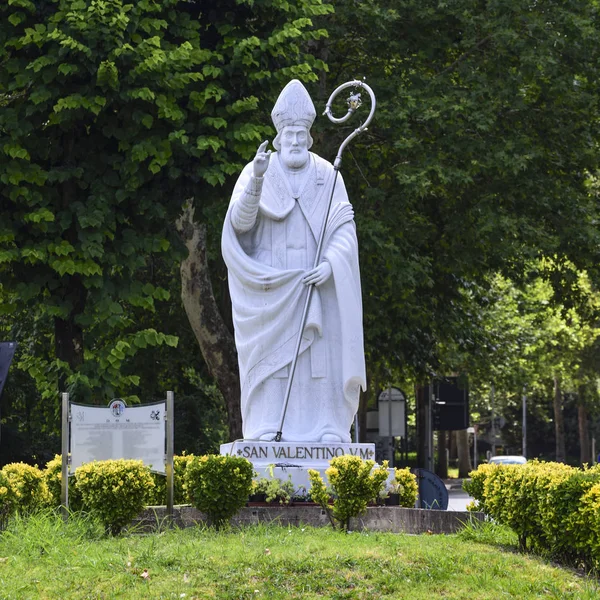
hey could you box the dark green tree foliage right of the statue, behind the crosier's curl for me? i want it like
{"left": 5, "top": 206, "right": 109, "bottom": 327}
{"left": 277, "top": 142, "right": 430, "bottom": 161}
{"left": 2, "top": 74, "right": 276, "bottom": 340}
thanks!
{"left": 326, "top": 0, "right": 600, "bottom": 376}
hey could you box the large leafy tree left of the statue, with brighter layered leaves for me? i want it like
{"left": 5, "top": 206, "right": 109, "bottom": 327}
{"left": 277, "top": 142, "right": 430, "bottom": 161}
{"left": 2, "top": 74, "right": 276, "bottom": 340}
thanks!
{"left": 0, "top": 0, "right": 330, "bottom": 435}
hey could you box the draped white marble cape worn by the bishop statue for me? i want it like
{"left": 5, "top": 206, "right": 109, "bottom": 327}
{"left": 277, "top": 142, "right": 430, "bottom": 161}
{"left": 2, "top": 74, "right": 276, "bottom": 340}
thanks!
{"left": 222, "top": 153, "right": 366, "bottom": 438}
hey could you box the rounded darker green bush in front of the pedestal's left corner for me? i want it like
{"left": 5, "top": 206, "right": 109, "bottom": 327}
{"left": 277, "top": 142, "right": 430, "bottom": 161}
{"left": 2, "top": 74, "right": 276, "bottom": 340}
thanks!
{"left": 184, "top": 455, "right": 254, "bottom": 528}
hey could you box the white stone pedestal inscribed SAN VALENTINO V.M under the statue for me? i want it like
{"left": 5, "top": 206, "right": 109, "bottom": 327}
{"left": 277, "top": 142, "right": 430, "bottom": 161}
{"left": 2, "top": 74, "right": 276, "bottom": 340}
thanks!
{"left": 221, "top": 440, "right": 375, "bottom": 491}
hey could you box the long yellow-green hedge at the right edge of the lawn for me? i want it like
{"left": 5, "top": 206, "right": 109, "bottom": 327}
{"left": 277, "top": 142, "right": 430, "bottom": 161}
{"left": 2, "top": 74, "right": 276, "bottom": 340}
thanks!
{"left": 464, "top": 461, "right": 600, "bottom": 571}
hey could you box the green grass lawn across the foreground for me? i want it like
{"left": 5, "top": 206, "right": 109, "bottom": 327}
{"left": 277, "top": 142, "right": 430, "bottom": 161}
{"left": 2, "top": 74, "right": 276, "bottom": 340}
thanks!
{"left": 0, "top": 515, "right": 600, "bottom": 600}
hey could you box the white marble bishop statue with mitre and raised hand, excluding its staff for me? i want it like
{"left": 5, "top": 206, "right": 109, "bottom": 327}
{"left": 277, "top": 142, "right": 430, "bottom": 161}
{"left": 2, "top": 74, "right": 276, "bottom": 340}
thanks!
{"left": 222, "top": 80, "right": 366, "bottom": 442}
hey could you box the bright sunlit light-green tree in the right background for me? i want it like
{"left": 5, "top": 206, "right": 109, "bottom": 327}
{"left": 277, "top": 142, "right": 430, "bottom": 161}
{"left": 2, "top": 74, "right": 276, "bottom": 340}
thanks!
{"left": 454, "top": 268, "right": 600, "bottom": 462}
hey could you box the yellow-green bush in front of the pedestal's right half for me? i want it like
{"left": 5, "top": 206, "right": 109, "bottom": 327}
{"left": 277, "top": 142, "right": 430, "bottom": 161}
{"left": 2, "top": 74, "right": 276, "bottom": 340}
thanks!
{"left": 308, "top": 455, "right": 388, "bottom": 530}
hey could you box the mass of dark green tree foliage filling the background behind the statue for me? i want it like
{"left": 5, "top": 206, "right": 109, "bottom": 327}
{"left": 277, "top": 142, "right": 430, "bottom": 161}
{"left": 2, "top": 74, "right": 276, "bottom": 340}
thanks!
{"left": 0, "top": 0, "right": 600, "bottom": 464}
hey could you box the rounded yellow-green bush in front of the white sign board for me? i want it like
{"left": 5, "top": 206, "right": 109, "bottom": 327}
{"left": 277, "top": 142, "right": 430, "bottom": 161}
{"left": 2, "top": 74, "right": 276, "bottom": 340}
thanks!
{"left": 75, "top": 459, "right": 154, "bottom": 535}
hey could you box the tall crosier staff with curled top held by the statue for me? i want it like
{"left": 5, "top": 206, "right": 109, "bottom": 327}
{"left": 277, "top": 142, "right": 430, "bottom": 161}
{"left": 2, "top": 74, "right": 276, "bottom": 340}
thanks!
{"left": 274, "top": 79, "right": 376, "bottom": 442}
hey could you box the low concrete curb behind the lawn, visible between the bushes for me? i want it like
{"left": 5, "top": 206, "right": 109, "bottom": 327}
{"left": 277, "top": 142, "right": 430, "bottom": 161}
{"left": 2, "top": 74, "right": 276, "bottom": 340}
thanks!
{"left": 134, "top": 505, "right": 485, "bottom": 534}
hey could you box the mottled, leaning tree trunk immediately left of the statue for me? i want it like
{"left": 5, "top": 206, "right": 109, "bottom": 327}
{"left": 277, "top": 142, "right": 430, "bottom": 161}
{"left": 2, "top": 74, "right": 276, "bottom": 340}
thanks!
{"left": 177, "top": 202, "right": 242, "bottom": 440}
